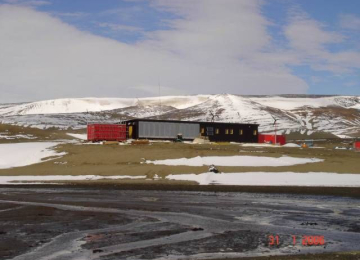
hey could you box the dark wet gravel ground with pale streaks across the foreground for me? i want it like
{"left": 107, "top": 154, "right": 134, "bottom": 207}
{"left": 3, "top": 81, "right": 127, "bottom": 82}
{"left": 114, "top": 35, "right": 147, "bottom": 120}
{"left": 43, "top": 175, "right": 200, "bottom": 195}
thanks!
{"left": 0, "top": 186, "right": 360, "bottom": 260}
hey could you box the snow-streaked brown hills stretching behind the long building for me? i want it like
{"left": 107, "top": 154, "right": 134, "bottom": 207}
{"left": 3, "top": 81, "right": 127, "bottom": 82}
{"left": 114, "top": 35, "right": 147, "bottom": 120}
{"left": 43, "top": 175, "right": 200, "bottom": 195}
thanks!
{"left": 0, "top": 94, "right": 360, "bottom": 137}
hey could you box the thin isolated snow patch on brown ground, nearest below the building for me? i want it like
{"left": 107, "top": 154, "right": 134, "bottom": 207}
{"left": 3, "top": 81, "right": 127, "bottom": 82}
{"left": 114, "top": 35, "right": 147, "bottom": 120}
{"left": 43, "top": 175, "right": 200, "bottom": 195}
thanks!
{"left": 146, "top": 156, "right": 323, "bottom": 167}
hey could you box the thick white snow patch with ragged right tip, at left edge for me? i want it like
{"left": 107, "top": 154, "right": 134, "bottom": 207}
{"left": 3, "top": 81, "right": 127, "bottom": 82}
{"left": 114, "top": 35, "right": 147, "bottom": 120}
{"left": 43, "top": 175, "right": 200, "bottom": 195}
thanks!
{"left": 0, "top": 142, "right": 65, "bottom": 169}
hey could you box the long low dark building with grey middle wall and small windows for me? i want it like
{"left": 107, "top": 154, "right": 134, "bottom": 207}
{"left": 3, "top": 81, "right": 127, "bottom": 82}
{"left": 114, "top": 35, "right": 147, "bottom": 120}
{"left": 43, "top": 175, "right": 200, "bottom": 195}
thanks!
{"left": 125, "top": 119, "right": 259, "bottom": 143}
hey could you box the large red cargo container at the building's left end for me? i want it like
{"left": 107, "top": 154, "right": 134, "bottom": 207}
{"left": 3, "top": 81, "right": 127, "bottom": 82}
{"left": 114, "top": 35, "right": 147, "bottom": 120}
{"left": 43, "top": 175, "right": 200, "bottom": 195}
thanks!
{"left": 87, "top": 124, "right": 126, "bottom": 142}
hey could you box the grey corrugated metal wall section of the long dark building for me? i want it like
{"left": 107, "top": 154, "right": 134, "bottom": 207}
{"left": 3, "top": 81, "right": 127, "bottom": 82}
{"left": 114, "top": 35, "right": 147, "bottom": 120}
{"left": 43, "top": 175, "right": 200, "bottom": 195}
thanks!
{"left": 139, "top": 121, "right": 200, "bottom": 139}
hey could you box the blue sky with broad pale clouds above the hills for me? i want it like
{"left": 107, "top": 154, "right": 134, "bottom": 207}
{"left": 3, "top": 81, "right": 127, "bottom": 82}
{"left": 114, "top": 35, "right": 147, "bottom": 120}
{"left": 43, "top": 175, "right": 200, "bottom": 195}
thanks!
{"left": 0, "top": 0, "right": 360, "bottom": 103}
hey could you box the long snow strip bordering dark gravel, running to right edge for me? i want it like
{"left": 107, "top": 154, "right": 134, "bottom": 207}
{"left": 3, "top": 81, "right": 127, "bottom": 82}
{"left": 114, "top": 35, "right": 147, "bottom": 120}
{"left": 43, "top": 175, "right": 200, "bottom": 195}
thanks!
{"left": 166, "top": 172, "right": 360, "bottom": 187}
